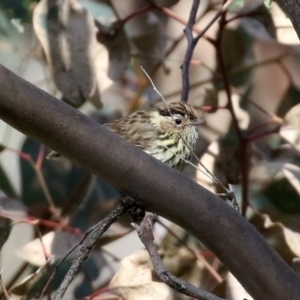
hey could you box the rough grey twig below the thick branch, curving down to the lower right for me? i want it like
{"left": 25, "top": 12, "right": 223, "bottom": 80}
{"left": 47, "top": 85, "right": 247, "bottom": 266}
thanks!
{"left": 133, "top": 213, "right": 224, "bottom": 300}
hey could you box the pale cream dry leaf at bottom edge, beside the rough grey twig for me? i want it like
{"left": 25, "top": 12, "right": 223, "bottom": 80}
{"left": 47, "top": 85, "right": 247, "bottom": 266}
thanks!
{"left": 109, "top": 250, "right": 172, "bottom": 300}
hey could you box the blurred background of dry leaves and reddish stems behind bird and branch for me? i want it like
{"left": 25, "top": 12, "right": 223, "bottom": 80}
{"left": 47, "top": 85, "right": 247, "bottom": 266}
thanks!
{"left": 0, "top": 0, "right": 300, "bottom": 300}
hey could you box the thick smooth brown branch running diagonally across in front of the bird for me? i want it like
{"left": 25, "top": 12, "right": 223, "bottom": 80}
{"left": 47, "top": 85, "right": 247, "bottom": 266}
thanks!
{"left": 0, "top": 65, "right": 300, "bottom": 300}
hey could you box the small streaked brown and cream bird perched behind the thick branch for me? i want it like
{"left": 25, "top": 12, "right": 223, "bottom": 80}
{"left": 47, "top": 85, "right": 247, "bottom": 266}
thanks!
{"left": 47, "top": 102, "right": 205, "bottom": 171}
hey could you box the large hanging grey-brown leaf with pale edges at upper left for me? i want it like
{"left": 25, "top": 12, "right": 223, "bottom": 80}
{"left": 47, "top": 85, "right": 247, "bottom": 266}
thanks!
{"left": 33, "top": 0, "right": 100, "bottom": 106}
